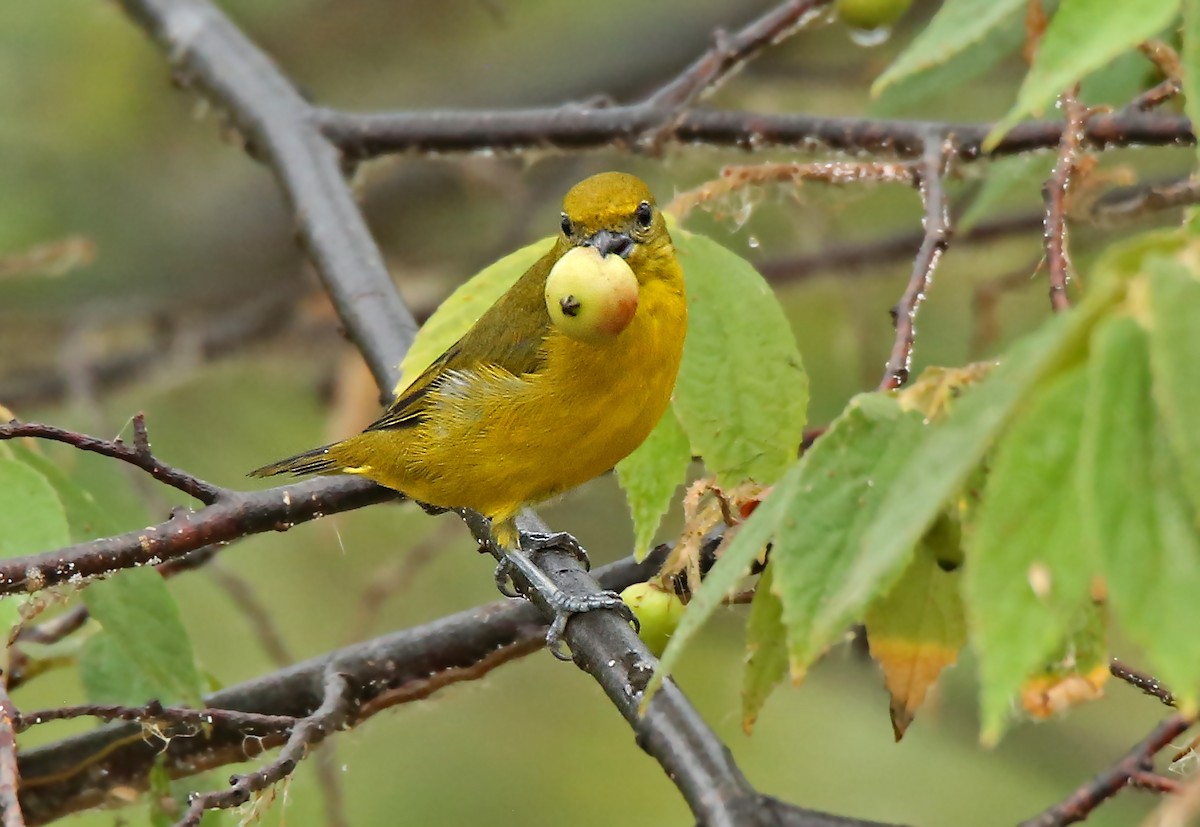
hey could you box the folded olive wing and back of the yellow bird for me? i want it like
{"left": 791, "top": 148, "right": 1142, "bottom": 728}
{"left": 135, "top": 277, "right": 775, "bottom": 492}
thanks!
{"left": 367, "top": 247, "right": 560, "bottom": 431}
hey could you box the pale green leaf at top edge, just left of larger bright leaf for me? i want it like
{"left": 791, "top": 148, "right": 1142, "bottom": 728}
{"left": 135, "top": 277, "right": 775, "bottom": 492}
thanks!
{"left": 871, "top": 0, "right": 1026, "bottom": 97}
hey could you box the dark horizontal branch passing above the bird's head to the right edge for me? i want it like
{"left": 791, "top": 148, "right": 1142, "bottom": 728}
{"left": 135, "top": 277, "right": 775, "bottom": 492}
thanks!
{"left": 313, "top": 104, "right": 1195, "bottom": 162}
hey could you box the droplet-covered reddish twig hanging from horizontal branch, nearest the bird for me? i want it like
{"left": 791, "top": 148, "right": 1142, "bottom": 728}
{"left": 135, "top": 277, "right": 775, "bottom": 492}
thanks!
{"left": 880, "top": 137, "right": 950, "bottom": 390}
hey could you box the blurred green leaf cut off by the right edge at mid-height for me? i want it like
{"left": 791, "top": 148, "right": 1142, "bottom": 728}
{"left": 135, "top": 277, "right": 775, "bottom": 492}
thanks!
{"left": 1146, "top": 258, "right": 1200, "bottom": 511}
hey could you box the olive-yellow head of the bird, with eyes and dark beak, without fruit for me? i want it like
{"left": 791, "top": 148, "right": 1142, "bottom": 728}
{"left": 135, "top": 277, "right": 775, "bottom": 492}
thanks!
{"left": 559, "top": 173, "right": 671, "bottom": 282}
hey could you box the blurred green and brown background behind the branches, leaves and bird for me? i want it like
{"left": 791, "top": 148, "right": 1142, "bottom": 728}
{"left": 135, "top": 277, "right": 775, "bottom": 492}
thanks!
{"left": 0, "top": 0, "right": 1190, "bottom": 827}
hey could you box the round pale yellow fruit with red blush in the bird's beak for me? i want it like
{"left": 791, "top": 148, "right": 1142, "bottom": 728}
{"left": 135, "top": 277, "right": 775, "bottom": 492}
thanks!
{"left": 546, "top": 247, "right": 637, "bottom": 344}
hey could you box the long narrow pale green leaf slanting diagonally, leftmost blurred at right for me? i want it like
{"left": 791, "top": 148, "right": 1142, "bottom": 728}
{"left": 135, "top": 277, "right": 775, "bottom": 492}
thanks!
{"left": 859, "top": 280, "right": 1124, "bottom": 612}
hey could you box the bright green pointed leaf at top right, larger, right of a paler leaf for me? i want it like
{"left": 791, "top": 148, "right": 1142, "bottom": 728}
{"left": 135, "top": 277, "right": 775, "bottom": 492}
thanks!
{"left": 984, "top": 0, "right": 1181, "bottom": 150}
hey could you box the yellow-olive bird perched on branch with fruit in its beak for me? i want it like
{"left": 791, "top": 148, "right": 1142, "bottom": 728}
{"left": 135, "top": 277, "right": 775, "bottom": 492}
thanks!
{"left": 252, "top": 173, "right": 688, "bottom": 643}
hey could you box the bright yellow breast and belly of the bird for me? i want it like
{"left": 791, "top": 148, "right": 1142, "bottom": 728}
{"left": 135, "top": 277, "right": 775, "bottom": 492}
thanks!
{"left": 349, "top": 264, "right": 686, "bottom": 520}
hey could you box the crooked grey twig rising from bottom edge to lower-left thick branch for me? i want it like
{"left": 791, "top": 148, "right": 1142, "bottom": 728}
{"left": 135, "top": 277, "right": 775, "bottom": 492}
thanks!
{"left": 176, "top": 671, "right": 353, "bottom": 827}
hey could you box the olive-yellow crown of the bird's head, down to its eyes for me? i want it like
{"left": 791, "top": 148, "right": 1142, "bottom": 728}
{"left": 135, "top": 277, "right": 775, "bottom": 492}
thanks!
{"left": 563, "top": 173, "right": 659, "bottom": 241}
